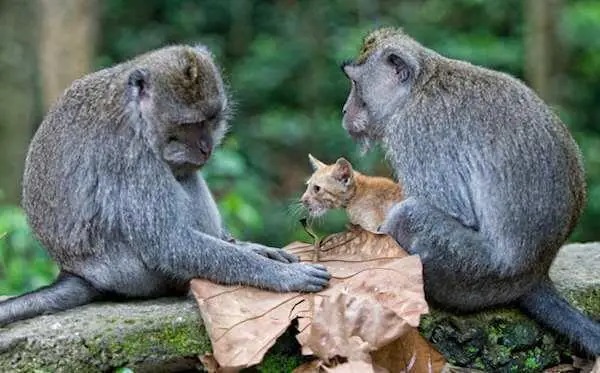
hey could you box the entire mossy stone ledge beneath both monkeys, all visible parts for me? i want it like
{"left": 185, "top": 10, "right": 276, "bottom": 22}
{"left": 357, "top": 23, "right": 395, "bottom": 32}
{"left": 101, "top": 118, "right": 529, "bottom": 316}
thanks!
{"left": 0, "top": 243, "right": 600, "bottom": 372}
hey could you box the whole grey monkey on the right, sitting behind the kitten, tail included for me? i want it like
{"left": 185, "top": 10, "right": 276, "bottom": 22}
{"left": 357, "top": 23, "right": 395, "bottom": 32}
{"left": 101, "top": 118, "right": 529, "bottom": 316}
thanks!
{"left": 342, "top": 28, "right": 600, "bottom": 355}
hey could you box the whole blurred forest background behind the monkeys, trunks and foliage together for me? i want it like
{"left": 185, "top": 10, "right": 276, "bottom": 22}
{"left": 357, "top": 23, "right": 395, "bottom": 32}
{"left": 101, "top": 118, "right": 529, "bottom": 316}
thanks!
{"left": 0, "top": 0, "right": 600, "bottom": 294}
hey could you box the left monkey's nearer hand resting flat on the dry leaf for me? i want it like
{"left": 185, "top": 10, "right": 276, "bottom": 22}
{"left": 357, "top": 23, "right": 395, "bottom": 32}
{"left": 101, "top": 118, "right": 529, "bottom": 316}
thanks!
{"left": 269, "top": 263, "right": 331, "bottom": 293}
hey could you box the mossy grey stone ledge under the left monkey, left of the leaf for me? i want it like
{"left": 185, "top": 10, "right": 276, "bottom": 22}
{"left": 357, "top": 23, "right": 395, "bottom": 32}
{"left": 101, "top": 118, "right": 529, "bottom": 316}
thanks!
{"left": 0, "top": 298, "right": 210, "bottom": 372}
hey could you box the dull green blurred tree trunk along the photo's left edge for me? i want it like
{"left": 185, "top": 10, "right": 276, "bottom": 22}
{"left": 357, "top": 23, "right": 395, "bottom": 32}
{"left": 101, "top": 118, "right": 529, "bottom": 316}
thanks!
{"left": 0, "top": 0, "right": 39, "bottom": 204}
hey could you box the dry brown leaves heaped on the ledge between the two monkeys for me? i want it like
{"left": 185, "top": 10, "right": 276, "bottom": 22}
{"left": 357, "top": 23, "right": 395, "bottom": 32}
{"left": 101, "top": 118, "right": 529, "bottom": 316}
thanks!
{"left": 191, "top": 228, "right": 443, "bottom": 372}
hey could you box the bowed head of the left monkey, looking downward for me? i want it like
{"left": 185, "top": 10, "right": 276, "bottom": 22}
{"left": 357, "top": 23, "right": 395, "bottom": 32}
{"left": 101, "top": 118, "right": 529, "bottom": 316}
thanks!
{"left": 126, "top": 46, "right": 229, "bottom": 174}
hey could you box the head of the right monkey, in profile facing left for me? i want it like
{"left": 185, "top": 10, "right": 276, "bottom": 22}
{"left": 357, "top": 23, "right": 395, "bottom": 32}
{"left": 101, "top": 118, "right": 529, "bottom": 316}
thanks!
{"left": 341, "top": 28, "right": 423, "bottom": 148}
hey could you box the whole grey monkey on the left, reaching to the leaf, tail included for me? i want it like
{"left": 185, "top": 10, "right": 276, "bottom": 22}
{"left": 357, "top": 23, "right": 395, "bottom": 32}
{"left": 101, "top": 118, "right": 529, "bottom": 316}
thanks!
{"left": 0, "top": 46, "right": 329, "bottom": 325}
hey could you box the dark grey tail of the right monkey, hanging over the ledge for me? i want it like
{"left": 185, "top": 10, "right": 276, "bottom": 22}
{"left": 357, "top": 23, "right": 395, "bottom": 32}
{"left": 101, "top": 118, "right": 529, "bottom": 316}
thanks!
{"left": 519, "top": 279, "right": 600, "bottom": 356}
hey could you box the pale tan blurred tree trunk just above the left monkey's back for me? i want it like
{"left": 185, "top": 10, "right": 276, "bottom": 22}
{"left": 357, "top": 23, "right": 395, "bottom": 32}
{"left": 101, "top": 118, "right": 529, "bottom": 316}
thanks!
{"left": 38, "top": 0, "right": 100, "bottom": 109}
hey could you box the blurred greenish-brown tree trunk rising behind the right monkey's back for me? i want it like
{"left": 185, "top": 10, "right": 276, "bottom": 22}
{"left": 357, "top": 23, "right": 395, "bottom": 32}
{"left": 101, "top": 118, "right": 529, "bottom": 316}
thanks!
{"left": 525, "top": 0, "right": 561, "bottom": 104}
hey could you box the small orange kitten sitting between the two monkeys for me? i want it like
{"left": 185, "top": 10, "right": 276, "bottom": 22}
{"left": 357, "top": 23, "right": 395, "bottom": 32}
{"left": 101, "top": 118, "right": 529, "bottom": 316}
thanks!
{"left": 300, "top": 154, "right": 403, "bottom": 232}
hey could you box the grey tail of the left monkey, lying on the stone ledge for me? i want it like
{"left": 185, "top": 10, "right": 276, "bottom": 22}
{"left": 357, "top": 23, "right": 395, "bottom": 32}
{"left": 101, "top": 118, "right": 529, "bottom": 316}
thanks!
{"left": 0, "top": 271, "right": 102, "bottom": 326}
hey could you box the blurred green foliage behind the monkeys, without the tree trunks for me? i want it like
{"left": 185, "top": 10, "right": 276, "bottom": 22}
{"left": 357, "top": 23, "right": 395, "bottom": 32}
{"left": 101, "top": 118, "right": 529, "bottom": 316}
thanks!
{"left": 0, "top": 0, "right": 600, "bottom": 292}
